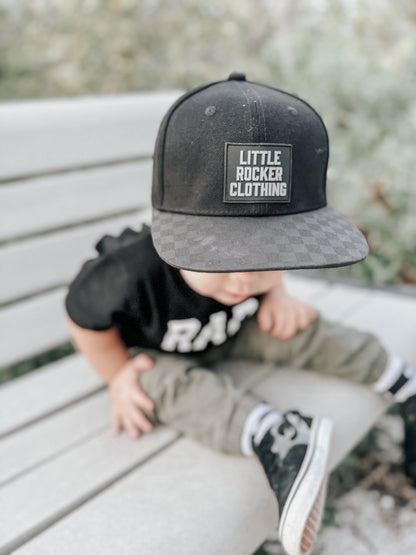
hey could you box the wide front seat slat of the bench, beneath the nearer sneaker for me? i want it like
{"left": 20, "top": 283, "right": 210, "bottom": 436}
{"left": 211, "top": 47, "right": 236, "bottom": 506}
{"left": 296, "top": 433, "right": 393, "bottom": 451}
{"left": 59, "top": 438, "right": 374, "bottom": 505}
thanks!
{"left": 10, "top": 439, "right": 277, "bottom": 555}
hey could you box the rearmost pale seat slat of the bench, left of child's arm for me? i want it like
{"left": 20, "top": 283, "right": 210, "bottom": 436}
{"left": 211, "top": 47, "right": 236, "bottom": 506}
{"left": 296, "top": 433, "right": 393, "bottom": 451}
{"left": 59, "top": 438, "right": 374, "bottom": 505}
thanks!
{"left": 0, "top": 354, "right": 104, "bottom": 436}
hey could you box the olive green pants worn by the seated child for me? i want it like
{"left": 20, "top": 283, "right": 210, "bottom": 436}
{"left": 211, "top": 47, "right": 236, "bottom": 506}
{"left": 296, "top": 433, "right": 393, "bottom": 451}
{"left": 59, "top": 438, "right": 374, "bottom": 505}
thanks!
{"left": 136, "top": 316, "right": 388, "bottom": 454}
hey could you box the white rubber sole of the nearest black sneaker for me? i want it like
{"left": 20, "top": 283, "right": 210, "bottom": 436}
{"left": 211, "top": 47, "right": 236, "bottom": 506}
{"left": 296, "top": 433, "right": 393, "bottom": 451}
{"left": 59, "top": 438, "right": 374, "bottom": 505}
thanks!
{"left": 279, "top": 418, "right": 332, "bottom": 555}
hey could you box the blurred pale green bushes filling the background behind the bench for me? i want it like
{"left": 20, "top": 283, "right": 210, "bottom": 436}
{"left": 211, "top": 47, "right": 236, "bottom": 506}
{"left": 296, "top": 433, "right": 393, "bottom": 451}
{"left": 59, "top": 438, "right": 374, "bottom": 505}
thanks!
{"left": 0, "top": 0, "right": 416, "bottom": 283}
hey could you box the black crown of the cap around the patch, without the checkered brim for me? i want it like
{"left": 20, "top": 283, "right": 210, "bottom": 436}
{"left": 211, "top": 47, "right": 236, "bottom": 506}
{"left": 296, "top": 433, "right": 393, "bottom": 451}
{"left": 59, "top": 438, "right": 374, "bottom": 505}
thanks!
{"left": 153, "top": 81, "right": 328, "bottom": 216}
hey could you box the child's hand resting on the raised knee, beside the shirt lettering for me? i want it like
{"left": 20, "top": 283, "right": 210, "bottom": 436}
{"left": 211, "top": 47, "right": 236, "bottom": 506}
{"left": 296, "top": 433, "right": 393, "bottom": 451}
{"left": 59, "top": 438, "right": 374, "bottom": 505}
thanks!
{"left": 257, "top": 288, "right": 317, "bottom": 341}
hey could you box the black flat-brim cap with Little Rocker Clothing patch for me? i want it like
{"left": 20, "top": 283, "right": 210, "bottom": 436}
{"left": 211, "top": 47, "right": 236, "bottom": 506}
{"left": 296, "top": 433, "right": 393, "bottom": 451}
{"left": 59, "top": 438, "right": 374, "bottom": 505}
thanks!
{"left": 152, "top": 73, "right": 368, "bottom": 272}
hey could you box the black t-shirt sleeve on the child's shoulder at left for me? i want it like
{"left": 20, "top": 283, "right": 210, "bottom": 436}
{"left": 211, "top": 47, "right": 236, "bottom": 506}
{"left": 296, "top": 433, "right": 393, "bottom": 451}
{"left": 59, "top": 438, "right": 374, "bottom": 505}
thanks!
{"left": 65, "top": 255, "right": 129, "bottom": 331}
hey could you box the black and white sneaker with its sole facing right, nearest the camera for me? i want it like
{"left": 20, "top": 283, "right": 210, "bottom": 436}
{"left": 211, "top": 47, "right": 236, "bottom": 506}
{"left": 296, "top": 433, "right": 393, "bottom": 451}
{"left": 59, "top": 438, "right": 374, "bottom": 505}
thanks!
{"left": 253, "top": 411, "right": 332, "bottom": 555}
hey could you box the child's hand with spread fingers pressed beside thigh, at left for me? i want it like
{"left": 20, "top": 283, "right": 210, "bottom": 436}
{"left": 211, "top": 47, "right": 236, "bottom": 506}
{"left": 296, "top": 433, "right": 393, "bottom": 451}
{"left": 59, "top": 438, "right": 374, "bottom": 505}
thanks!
{"left": 109, "top": 354, "right": 155, "bottom": 439}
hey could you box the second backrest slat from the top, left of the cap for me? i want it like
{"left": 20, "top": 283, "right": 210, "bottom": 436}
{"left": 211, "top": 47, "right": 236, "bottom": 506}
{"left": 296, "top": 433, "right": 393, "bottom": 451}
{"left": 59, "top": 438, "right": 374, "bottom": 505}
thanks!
{"left": 0, "top": 161, "right": 152, "bottom": 241}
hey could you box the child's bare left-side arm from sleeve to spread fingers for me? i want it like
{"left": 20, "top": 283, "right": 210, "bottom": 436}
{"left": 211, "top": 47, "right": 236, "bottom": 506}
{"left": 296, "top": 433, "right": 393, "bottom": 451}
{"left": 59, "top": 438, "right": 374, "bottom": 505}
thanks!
{"left": 69, "top": 319, "right": 154, "bottom": 439}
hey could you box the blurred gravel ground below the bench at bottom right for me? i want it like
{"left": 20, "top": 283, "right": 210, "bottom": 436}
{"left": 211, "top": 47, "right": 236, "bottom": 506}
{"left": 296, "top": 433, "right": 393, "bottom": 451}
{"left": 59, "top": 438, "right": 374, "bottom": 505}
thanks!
{"left": 256, "top": 415, "right": 416, "bottom": 555}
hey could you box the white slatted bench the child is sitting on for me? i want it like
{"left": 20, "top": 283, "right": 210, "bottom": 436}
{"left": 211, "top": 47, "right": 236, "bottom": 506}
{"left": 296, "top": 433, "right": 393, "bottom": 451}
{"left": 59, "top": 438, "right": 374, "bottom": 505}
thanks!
{"left": 0, "top": 91, "right": 416, "bottom": 555}
